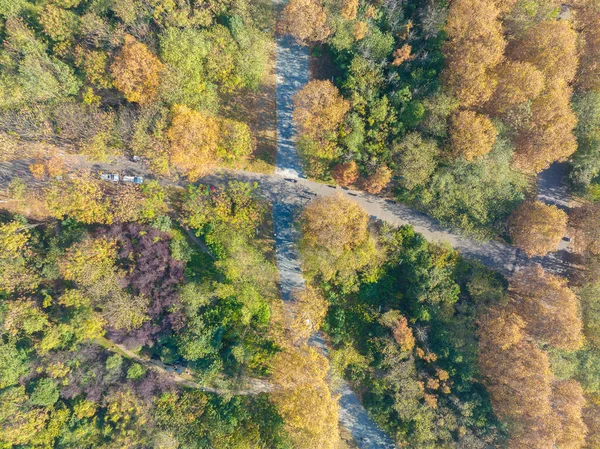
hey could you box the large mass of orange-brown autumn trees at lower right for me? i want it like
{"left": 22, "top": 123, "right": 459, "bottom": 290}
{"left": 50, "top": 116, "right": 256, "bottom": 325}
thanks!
{"left": 479, "top": 265, "right": 587, "bottom": 449}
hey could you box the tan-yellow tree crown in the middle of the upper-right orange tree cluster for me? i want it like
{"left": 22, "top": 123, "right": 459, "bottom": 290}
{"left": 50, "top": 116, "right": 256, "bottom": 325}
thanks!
{"left": 488, "top": 61, "right": 544, "bottom": 114}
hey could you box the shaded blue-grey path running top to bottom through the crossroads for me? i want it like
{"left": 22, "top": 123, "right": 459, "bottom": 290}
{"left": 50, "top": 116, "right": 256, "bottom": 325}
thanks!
{"left": 273, "top": 17, "right": 395, "bottom": 449}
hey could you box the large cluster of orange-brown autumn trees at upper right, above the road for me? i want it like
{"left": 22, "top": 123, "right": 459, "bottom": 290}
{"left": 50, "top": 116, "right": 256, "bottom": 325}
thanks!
{"left": 444, "top": 0, "right": 578, "bottom": 173}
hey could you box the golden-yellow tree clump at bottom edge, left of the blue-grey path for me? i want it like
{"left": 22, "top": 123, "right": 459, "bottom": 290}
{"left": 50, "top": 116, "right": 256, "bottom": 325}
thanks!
{"left": 271, "top": 346, "right": 340, "bottom": 449}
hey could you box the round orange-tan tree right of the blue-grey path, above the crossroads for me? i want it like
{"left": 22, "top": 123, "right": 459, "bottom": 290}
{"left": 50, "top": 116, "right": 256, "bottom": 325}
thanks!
{"left": 294, "top": 80, "right": 350, "bottom": 140}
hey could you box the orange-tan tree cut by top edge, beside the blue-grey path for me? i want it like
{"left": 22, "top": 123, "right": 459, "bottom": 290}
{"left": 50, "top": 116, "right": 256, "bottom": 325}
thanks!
{"left": 282, "top": 0, "right": 331, "bottom": 44}
